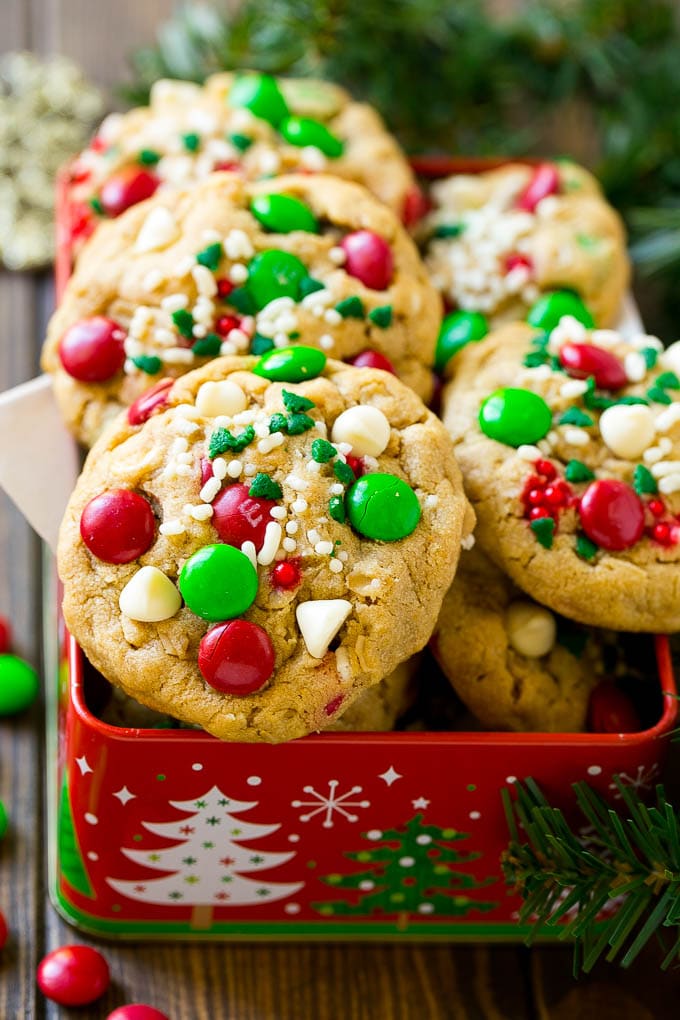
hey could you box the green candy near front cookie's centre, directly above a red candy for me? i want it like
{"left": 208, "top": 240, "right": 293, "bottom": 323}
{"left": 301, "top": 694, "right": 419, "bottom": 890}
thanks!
{"left": 179, "top": 544, "right": 257, "bottom": 622}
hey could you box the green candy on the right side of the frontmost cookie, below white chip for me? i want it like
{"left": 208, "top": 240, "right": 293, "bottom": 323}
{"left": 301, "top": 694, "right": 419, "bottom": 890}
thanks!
{"left": 347, "top": 472, "right": 420, "bottom": 542}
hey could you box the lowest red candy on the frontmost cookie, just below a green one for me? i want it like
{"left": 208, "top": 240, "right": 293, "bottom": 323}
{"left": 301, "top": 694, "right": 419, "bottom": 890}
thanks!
{"left": 199, "top": 620, "right": 275, "bottom": 695}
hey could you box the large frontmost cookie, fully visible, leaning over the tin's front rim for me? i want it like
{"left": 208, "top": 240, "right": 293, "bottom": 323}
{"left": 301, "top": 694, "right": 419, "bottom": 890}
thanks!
{"left": 58, "top": 347, "right": 473, "bottom": 742}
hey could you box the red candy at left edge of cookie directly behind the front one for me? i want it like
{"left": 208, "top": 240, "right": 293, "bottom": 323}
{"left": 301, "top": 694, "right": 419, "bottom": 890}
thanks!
{"left": 59, "top": 315, "right": 125, "bottom": 383}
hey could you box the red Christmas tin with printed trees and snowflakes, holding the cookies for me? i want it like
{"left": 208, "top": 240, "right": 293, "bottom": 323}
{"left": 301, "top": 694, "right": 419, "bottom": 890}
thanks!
{"left": 47, "top": 153, "right": 676, "bottom": 939}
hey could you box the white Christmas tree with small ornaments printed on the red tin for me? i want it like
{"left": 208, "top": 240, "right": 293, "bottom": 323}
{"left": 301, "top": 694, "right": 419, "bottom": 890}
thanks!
{"left": 106, "top": 786, "right": 304, "bottom": 928}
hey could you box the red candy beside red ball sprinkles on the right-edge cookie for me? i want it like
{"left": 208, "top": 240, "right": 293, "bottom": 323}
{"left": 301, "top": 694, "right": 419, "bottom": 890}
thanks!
{"left": 579, "top": 478, "right": 644, "bottom": 552}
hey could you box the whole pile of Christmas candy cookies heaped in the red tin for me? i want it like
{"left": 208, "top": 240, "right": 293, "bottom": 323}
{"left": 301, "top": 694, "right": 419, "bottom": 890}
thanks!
{"left": 44, "top": 74, "right": 680, "bottom": 742}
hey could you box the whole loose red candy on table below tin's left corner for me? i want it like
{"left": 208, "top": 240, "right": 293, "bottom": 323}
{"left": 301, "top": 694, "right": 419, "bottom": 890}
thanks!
{"left": 38, "top": 946, "right": 111, "bottom": 1006}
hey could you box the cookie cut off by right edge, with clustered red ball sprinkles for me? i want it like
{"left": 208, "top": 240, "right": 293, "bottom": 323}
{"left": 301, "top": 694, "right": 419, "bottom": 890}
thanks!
{"left": 443, "top": 317, "right": 680, "bottom": 632}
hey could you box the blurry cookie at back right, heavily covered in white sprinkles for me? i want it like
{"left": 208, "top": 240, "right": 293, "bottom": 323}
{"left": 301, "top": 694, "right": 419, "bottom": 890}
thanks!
{"left": 420, "top": 160, "right": 630, "bottom": 325}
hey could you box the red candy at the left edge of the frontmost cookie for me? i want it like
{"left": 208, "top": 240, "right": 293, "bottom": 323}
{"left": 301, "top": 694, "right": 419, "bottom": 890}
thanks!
{"left": 81, "top": 489, "right": 156, "bottom": 563}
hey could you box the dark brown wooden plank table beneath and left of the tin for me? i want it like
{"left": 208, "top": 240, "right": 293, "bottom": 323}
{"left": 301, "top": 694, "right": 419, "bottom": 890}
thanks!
{"left": 0, "top": 0, "right": 680, "bottom": 1020}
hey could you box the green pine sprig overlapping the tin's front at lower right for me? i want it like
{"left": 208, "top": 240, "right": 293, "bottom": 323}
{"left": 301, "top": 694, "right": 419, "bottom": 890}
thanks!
{"left": 503, "top": 776, "right": 680, "bottom": 973}
